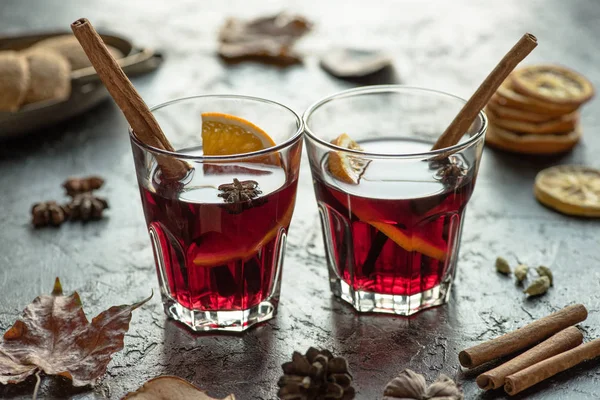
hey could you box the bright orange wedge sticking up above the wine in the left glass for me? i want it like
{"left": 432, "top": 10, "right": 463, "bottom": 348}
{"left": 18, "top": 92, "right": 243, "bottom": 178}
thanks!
{"left": 202, "top": 112, "right": 279, "bottom": 164}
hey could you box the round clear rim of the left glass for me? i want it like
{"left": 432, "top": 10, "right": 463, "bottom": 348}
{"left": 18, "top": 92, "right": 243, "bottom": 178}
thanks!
{"left": 127, "top": 94, "right": 304, "bottom": 161}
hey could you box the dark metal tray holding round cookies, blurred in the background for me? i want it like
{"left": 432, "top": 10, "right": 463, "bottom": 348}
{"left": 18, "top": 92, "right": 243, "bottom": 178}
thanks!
{"left": 0, "top": 31, "right": 163, "bottom": 139}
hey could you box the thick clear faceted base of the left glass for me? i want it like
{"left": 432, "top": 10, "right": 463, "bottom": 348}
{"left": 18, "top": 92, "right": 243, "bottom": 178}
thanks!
{"left": 163, "top": 295, "right": 277, "bottom": 332}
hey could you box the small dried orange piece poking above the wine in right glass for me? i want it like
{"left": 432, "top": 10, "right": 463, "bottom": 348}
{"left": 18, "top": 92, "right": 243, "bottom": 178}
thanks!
{"left": 327, "top": 133, "right": 369, "bottom": 185}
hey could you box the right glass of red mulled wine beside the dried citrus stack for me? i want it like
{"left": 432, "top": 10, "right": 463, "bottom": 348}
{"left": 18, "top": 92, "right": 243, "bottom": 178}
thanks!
{"left": 303, "top": 85, "right": 487, "bottom": 315}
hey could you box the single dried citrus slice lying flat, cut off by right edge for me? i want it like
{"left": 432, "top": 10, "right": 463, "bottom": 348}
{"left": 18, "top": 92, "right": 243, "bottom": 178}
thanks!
{"left": 534, "top": 165, "right": 600, "bottom": 217}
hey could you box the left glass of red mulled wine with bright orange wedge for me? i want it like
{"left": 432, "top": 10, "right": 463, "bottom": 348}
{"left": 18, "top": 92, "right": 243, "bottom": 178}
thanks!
{"left": 130, "top": 95, "right": 303, "bottom": 331}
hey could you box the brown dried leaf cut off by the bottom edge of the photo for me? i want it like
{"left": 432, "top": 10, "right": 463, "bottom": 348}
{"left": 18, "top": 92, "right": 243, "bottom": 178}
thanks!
{"left": 123, "top": 376, "right": 235, "bottom": 400}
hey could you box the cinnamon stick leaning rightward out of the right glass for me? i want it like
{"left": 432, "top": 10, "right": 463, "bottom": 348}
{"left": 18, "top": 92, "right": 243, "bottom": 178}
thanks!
{"left": 432, "top": 33, "right": 537, "bottom": 150}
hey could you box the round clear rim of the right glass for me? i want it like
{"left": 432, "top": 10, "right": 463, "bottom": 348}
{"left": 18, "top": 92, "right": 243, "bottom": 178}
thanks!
{"left": 302, "top": 84, "right": 488, "bottom": 159}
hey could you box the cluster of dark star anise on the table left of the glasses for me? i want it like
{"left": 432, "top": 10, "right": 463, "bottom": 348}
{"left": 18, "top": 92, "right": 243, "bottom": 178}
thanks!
{"left": 31, "top": 176, "right": 108, "bottom": 228}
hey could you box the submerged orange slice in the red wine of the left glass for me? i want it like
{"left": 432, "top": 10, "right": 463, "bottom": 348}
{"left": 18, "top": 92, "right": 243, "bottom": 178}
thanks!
{"left": 193, "top": 196, "right": 295, "bottom": 267}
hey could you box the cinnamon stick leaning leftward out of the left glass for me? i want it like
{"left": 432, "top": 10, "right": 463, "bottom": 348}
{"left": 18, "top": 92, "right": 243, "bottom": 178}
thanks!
{"left": 71, "top": 18, "right": 189, "bottom": 179}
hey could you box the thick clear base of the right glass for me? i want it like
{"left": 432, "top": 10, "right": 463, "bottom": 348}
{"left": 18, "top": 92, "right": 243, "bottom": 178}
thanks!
{"left": 331, "top": 279, "right": 452, "bottom": 316}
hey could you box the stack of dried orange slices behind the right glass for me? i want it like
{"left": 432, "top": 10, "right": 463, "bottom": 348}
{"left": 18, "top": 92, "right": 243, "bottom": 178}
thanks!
{"left": 485, "top": 65, "right": 594, "bottom": 154}
